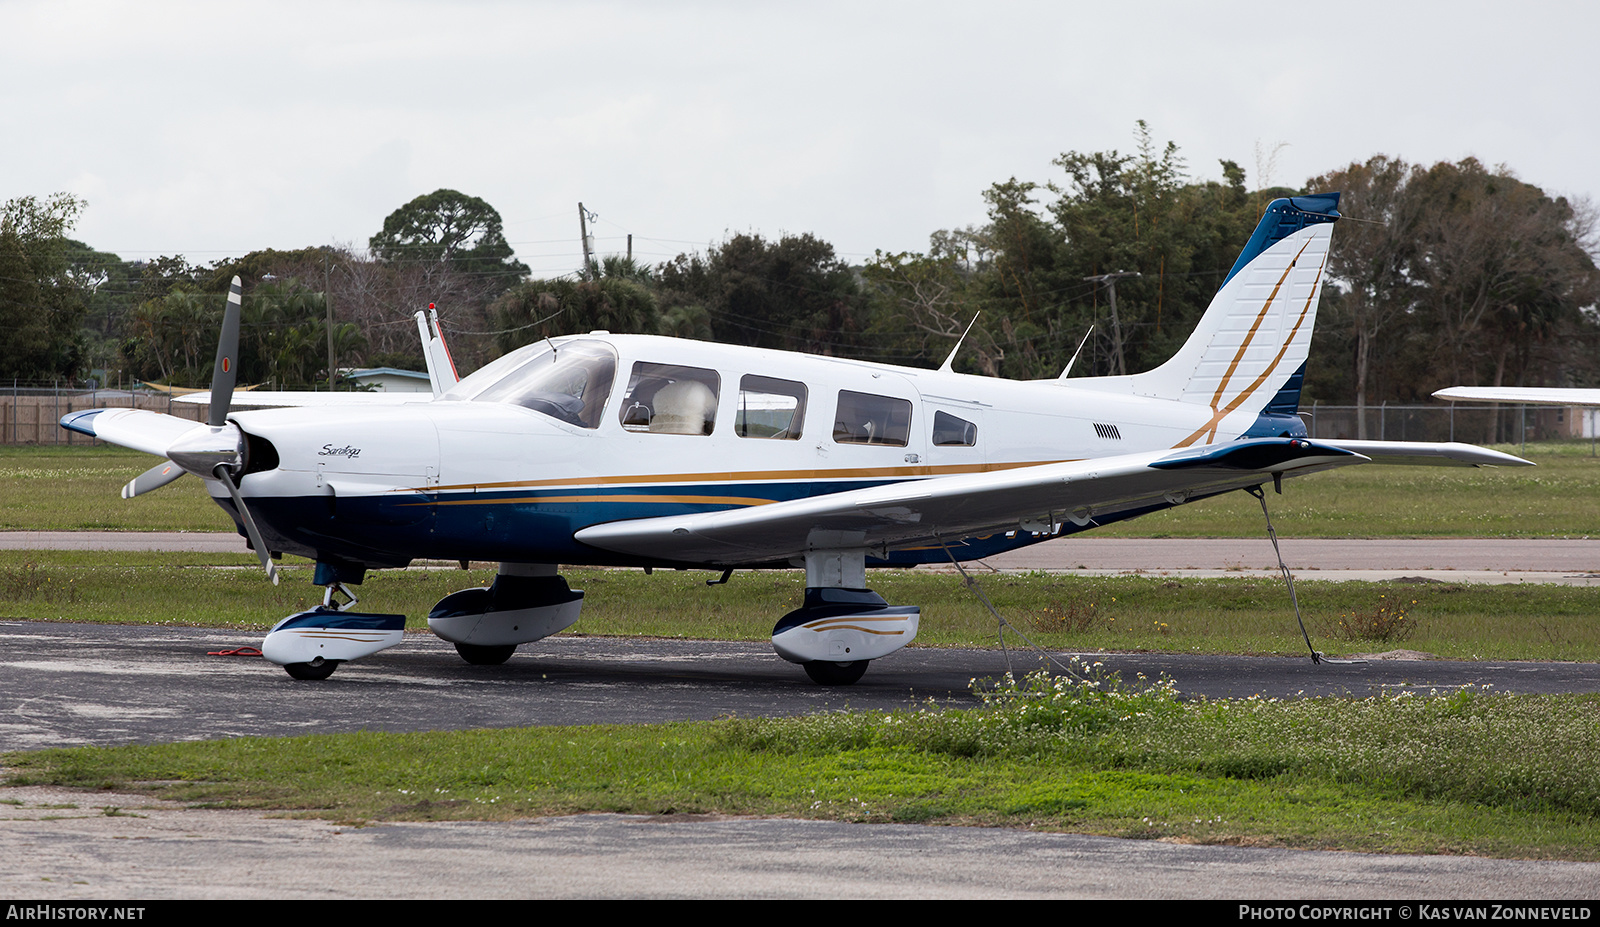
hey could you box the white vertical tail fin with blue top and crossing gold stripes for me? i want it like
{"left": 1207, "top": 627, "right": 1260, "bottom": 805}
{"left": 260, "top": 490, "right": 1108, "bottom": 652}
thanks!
{"left": 1128, "top": 194, "right": 1339, "bottom": 447}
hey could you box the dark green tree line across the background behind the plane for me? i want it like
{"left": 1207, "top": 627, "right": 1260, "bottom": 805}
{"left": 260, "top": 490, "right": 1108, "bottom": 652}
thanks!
{"left": 0, "top": 122, "right": 1600, "bottom": 416}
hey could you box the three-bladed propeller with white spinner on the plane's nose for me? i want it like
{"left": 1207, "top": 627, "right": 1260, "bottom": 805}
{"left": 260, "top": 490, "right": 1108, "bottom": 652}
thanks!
{"left": 122, "top": 277, "right": 278, "bottom": 586}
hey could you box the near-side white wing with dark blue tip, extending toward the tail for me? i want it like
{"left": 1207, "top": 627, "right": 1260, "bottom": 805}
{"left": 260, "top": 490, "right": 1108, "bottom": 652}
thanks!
{"left": 576, "top": 439, "right": 1363, "bottom": 565}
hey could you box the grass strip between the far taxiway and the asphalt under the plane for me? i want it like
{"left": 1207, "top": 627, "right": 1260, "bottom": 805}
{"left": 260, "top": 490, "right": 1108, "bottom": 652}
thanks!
{"left": 9, "top": 551, "right": 1600, "bottom": 661}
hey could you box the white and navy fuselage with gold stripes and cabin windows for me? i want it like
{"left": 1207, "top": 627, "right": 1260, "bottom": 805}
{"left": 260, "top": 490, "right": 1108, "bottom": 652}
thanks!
{"left": 213, "top": 333, "right": 1228, "bottom": 565}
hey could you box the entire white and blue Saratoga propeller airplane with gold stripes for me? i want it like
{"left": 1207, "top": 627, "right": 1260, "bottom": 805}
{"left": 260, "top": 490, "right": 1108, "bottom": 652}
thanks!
{"left": 61, "top": 194, "right": 1526, "bottom": 685}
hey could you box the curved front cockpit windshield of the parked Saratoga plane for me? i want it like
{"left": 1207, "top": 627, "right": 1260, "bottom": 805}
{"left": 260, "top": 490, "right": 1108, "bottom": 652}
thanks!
{"left": 440, "top": 341, "right": 616, "bottom": 427}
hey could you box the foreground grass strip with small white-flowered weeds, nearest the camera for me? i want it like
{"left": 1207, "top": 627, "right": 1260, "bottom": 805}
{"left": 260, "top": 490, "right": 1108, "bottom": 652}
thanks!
{"left": 6, "top": 676, "right": 1600, "bottom": 860}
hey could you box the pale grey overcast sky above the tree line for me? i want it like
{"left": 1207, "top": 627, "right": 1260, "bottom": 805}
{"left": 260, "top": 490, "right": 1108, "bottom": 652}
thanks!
{"left": 0, "top": 0, "right": 1600, "bottom": 275}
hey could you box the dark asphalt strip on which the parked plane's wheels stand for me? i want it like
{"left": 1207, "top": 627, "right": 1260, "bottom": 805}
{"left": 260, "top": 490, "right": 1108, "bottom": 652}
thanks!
{"left": 9, "top": 621, "right": 1600, "bottom": 749}
